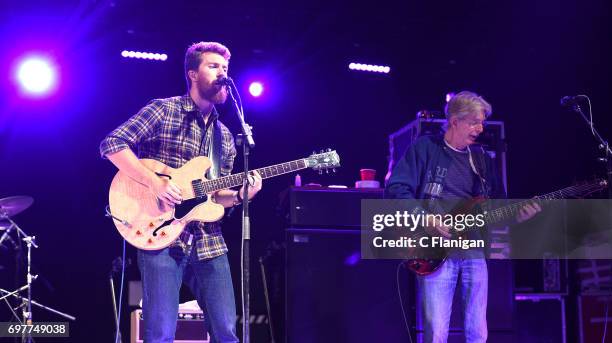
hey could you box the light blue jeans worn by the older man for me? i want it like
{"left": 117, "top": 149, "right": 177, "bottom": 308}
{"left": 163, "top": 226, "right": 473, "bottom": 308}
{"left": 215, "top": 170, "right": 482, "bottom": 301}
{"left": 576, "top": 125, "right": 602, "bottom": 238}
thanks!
{"left": 417, "top": 254, "right": 489, "bottom": 343}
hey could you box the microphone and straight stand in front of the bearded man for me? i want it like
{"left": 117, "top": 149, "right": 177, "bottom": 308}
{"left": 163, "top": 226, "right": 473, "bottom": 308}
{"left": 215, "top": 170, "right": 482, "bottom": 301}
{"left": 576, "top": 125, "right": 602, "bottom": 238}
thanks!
{"left": 225, "top": 77, "right": 255, "bottom": 343}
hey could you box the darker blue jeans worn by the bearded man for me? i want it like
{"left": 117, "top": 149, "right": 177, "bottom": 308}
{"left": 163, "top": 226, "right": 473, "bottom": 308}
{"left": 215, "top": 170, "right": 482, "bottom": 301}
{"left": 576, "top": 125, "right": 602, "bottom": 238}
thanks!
{"left": 138, "top": 246, "right": 238, "bottom": 343}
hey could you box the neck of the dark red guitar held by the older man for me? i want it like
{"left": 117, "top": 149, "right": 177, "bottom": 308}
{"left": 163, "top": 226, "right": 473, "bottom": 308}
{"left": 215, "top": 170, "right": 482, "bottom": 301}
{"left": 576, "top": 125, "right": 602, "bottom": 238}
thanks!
{"left": 484, "top": 183, "right": 601, "bottom": 224}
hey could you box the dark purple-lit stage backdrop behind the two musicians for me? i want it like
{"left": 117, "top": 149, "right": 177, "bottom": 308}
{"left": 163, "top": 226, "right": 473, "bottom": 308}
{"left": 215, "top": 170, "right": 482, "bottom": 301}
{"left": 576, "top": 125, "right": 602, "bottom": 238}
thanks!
{"left": 0, "top": 0, "right": 612, "bottom": 342}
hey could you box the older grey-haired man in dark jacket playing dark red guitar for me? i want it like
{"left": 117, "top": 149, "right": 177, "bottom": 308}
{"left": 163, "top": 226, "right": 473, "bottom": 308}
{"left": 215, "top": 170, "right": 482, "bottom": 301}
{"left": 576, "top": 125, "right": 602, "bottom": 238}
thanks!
{"left": 385, "top": 91, "right": 540, "bottom": 343}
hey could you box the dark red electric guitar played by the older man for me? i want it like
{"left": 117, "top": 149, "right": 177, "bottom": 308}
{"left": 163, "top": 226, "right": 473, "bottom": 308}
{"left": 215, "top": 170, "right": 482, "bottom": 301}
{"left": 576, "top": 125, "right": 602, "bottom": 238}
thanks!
{"left": 405, "top": 179, "right": 608, "bottom": 276}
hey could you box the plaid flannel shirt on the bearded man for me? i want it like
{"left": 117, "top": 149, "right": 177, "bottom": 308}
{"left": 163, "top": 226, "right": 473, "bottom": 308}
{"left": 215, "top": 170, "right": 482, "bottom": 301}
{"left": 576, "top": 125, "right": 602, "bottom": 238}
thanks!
{"left": 100, "top": 95, "right": 236, "bottom": 259}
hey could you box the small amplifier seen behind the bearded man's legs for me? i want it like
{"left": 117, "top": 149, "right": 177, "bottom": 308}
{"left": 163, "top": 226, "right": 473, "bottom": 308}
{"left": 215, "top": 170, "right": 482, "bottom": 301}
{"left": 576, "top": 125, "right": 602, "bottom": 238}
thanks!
{"left": 130, "top": 309, "right": 210, "bottom": 343}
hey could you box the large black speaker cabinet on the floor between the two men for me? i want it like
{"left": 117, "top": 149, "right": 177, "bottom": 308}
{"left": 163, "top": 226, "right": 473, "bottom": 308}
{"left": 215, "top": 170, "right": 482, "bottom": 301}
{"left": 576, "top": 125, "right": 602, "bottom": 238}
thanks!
{"left": 286, "top": 228, "right": 413, "bottom": 343}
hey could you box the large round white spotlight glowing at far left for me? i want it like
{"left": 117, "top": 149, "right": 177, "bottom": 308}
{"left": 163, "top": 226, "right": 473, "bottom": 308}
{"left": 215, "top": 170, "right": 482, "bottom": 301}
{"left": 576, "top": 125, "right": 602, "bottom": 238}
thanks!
{"left": 17, "top": 57, "right": 57, "bottom": 95}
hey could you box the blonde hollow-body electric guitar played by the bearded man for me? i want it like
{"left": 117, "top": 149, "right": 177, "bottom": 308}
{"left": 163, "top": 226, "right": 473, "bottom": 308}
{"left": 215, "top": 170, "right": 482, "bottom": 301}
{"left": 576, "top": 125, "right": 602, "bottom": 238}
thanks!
{"left": 109, "top": 151, "right": 340, "bottom": 250}
